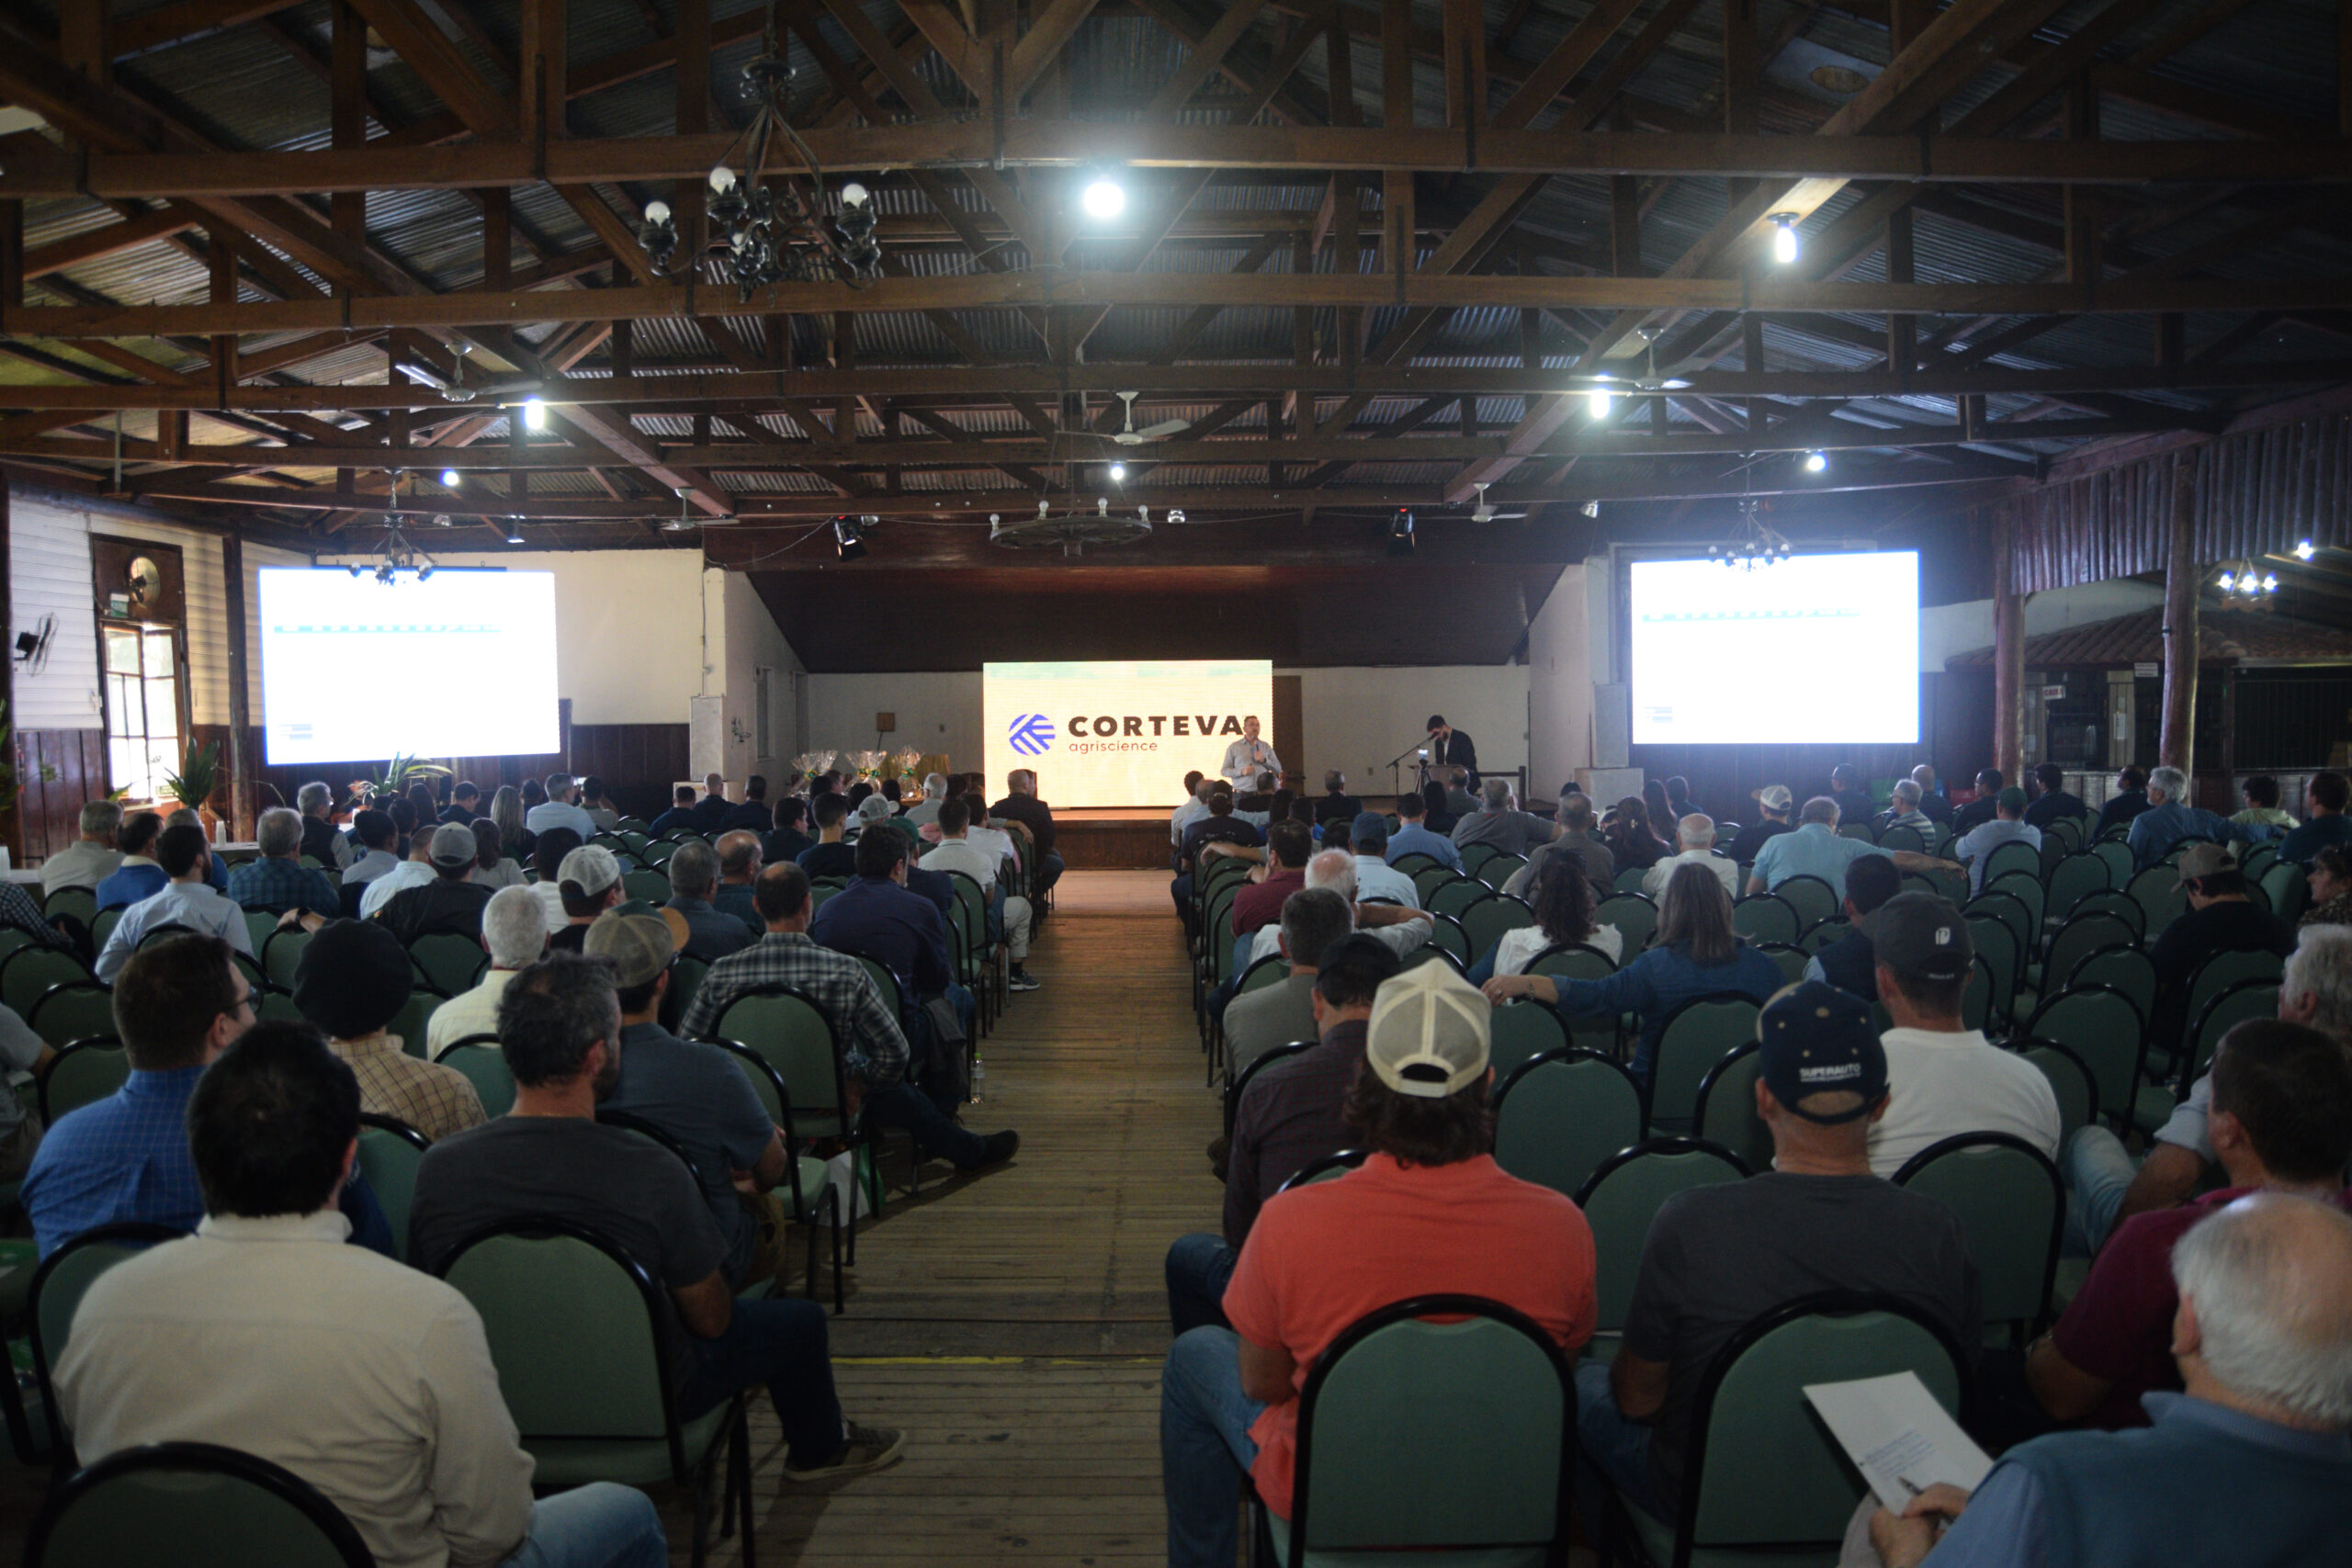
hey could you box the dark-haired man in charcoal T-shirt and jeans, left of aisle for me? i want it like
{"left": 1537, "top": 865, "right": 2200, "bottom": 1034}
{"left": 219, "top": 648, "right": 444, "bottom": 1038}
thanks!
{"left": 409, "top": 949, "right": 906, "bottom": 1481}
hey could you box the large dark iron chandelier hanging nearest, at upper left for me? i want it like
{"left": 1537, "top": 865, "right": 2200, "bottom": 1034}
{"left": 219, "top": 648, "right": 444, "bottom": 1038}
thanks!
{"left": 638, "top": 7, "right": 882, "bottom": 301}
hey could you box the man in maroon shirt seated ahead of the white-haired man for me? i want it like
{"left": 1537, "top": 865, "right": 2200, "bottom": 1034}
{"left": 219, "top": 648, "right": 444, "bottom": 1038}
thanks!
{"left": 2025, "top": 1018, "right": 2352, "bottom": 1429}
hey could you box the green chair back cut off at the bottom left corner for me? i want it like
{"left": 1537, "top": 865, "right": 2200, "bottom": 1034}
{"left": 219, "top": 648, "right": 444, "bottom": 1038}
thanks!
{"left": 24, "top": 1443, "right": 377, "bottom": 1568}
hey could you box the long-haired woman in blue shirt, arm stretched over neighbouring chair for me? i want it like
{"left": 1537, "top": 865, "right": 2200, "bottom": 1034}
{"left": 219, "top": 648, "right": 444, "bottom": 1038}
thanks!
{"left": 1487, "top": 865, "right": 1781, "bottom": 1081}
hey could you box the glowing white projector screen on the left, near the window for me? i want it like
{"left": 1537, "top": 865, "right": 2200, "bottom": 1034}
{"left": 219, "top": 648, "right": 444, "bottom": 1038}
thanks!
{"left": 261, "top": 567, "right": 562, "bottom": 766}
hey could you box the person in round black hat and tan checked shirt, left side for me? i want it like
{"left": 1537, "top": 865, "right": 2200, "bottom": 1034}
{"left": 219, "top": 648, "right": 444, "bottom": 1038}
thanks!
{"left": 294, "top": 921, "right": 482, "bottom": 1143}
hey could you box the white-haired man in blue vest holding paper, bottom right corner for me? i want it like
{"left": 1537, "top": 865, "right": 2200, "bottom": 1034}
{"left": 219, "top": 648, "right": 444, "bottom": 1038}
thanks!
{"left": 1847, "top": 1192, "right": 2352, "bottom": 1568}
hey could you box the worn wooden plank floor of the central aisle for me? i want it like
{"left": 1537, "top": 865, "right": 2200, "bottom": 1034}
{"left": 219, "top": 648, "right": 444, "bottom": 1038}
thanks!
{"left": 659, "top": 872, "right": 1218, "bottom": 1568}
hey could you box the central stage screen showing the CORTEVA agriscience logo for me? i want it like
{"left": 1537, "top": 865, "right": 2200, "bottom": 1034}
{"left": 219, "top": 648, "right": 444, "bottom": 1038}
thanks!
{"left": 981, "top": 659, "right": 1275, "bottom": 808}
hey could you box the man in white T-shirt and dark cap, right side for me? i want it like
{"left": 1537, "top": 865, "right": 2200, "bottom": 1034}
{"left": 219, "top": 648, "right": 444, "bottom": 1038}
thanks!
{"left": 1870, "top": 894, "right": 2061, "bottom": 1176}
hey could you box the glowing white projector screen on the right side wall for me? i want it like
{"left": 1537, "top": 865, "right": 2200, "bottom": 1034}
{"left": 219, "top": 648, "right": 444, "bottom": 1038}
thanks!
{"left": 1633, "top": 550, "right": 1919, "bottom": 745}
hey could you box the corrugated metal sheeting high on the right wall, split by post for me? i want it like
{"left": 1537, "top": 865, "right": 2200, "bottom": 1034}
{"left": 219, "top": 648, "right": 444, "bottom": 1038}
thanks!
{"left": 1990, "top": 413, "right": 2352, "bottom": 592}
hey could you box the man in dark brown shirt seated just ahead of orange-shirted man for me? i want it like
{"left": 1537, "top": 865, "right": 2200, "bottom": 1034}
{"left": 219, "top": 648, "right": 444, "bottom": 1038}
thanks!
{"left": 1167, "top": 936, "right": 1402, "bottom": 1333}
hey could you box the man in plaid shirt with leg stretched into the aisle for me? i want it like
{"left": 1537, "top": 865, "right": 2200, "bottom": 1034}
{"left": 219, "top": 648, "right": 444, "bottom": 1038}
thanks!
{"left": 680, "top": 861, "right": 1021, "bottom": 1170}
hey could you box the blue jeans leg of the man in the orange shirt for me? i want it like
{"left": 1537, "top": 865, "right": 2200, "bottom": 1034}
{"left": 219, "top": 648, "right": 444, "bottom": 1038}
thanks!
{"left": 1159, "top": 1328, "right": 1265, "bottom": 1568}
